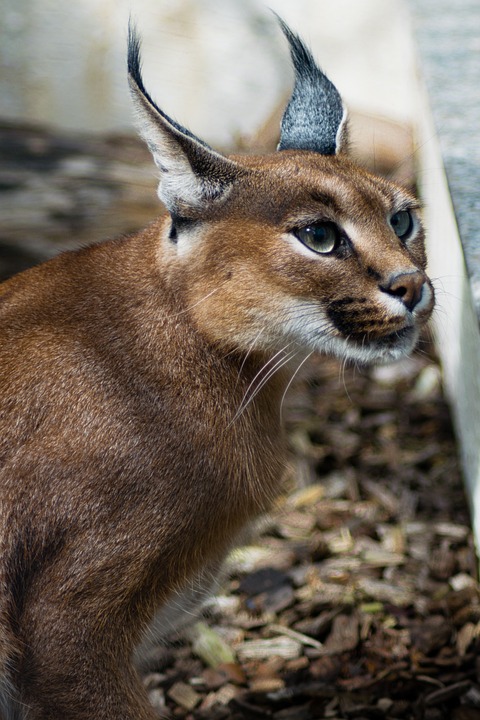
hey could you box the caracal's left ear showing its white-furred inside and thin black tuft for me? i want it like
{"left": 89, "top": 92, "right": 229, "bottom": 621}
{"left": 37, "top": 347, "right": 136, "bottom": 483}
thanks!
{"left": 128, "top": 23, "right": 241, "bottom": 217}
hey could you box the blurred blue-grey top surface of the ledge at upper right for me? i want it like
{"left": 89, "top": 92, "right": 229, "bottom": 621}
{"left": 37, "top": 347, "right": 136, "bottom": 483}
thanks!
{"left": 409, "top": 0, "right": 480, "bottom": 321}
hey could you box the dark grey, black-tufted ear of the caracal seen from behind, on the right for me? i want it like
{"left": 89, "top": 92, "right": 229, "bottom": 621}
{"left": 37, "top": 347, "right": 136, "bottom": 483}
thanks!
{"left": 277, "top": 16, "right": 348, "bottom": 155}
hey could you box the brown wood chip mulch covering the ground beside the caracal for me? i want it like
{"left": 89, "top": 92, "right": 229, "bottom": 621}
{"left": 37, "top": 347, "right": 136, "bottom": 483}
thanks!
{"left": 139, "top": 344, "right": 480, "bottom": 720}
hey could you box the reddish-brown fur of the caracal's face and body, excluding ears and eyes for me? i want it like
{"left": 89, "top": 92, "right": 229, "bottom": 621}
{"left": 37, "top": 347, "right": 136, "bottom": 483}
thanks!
{"left": 0, "top": 28, "right": 433, "bottom": 720}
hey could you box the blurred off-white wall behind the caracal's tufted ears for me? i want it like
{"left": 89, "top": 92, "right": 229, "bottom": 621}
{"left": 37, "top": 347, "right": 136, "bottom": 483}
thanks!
{"left": 0, "top": 0, "right": 413, "bottom": 145}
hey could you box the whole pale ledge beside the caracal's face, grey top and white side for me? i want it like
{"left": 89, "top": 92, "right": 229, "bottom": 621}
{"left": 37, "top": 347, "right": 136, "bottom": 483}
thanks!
{"left": 410, "top": 0, "right": 480, "bottom": 547}
